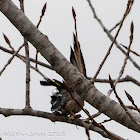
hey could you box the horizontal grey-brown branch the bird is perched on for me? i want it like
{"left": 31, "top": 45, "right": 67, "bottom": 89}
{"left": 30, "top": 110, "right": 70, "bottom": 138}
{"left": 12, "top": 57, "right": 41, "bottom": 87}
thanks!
{"left": 0, "top": 108, "right": 124, "bottom": 140}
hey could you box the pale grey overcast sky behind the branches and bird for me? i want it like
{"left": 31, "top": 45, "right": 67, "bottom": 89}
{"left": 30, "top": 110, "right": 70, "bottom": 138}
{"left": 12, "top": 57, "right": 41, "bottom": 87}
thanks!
{"left": 0, "top": 0, "right": 140, "bottom": 140}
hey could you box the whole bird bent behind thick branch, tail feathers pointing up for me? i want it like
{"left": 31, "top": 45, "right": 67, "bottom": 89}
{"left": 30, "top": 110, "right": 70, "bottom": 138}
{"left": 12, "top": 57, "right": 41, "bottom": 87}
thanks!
{"left": 40, "top": 33, "right": 86, "bottom": 115}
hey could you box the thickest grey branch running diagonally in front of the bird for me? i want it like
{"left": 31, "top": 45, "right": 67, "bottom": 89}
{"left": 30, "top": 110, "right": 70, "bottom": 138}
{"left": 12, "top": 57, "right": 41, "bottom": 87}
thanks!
{"left": 0, "top": 0, "right": 140, "bottom": 132}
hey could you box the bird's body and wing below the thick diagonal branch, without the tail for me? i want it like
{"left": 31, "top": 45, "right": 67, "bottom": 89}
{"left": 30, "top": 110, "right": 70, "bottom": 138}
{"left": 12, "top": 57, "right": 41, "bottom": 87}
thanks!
{"left": 40, "top": 80, "right": 84, "bottom": 115}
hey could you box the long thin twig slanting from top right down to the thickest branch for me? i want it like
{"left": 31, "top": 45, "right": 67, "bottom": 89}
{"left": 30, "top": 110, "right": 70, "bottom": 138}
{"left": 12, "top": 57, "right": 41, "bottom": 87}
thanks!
{"left": 92, "top": 0, "right": 133, "bottom": 83}
